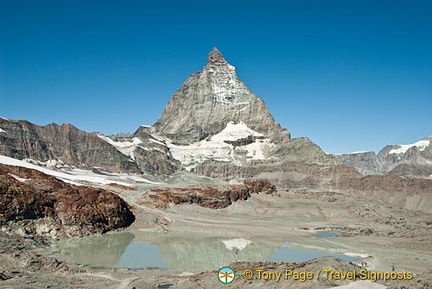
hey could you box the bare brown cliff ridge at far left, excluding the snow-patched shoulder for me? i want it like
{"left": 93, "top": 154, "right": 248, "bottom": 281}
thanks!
{"left": 0, "top": 118, "right": 141, "bottom": 173}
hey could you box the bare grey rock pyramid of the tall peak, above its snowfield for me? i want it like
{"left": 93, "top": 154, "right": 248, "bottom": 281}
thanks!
{"left": 149, "top": 48, "right": 289, "bottom": 145}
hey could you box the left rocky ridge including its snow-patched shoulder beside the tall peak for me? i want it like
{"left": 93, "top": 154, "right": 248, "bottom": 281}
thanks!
{"left": 0, "top": 118, "right": 180, "bottom": 176}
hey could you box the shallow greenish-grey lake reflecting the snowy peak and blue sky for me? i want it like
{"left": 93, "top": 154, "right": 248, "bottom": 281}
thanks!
{"left": 53, "top": 232, "right": 356, "bottom": 270}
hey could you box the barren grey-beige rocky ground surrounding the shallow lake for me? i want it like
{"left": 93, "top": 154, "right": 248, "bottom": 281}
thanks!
{"left": 0, "top": 172, "right": 432, "bottom": 288}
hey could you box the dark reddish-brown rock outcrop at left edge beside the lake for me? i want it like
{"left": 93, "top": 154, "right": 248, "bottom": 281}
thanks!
{"left": 0, "top": 165, "right": 135, "bottom": 237}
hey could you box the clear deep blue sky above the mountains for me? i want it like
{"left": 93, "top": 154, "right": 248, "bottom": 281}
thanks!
{"left": 0, "top": 0, "right": 432, "bottom": 153}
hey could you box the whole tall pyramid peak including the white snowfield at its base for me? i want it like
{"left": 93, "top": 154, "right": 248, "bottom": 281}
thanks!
{"left": 135, "top": 48, "right": 337, "bottom": 171}
